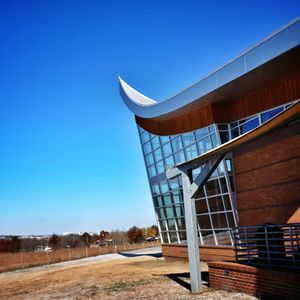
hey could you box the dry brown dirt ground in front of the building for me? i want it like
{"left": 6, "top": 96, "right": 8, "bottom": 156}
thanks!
{"left": 0, "top": 256, "right": 256, "bottom": 300}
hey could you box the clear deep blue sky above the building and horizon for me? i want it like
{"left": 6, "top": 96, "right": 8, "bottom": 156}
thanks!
{"left": 0, "top": 0, "right": 300, "bottom": 235}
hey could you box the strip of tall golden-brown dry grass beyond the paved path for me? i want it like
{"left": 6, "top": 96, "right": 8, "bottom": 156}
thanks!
{"left": 0, "top": 242, "right": 160, "bottom": 273}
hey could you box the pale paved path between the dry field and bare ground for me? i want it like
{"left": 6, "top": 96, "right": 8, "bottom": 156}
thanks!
{"left": 0, "top": 247, "right": 161, "bottom": 278}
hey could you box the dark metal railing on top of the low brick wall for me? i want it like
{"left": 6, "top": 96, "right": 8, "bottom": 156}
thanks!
{"left": 232, "top": 223, "right": 300, "bottom": 269}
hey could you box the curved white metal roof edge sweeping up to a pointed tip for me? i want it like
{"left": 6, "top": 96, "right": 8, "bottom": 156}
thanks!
{"left": 119, "top": 17, "right": 300, "bottom": 118}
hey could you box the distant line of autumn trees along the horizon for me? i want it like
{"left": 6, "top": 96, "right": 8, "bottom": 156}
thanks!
{"left": 0, "top": 225, "right": 159, "bottom": 253}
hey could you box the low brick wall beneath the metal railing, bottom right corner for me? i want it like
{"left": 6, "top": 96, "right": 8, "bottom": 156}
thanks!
{"left": 208, "top": 262, "right": 300, "bottom": 299}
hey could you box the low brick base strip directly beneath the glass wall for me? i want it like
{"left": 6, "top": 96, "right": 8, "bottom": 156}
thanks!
{"left": 162, "top": 244, "right": 235, "bottom": 261}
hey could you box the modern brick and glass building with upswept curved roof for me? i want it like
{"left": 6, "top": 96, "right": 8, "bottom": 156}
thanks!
{"left": 119, "top": 19, "right": 300, "bottom": 260}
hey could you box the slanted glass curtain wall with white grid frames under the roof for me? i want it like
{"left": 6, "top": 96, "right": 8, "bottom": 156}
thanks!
{"left": 138, "top": 104, "right": 291, "bottom": 245}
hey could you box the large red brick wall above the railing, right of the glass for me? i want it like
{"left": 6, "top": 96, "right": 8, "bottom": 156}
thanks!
{"left": 233, "top": 122, "right": 300, "bottom": 226}
